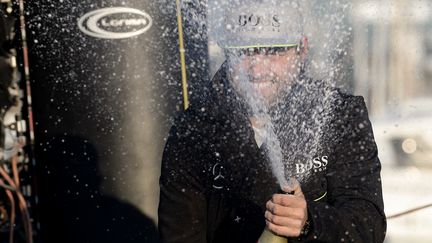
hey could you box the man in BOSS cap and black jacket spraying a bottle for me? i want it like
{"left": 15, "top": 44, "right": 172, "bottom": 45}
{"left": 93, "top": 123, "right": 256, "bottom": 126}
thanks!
{"left": 159, "top": 1, "right": 386, "bottom": 243}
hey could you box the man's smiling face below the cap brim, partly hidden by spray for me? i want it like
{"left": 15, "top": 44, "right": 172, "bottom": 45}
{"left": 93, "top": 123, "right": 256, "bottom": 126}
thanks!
{"left": 230, "top": 47, "right": 301, "bottom": 105}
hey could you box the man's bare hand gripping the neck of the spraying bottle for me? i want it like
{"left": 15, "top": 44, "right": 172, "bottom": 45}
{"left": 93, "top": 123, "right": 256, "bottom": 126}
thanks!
{"left": 264, "top": 179, "right": 308, "bottom": 237}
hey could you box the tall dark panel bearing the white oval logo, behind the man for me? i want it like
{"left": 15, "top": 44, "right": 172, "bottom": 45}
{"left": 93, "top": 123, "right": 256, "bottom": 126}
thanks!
{"left": 26, "top": 0, "right": 207, "bottom": 242}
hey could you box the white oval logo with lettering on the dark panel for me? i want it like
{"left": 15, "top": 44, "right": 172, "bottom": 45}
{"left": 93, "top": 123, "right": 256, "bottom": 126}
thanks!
{"left": 78, "top": 7, "right": 152, "bottom": 39}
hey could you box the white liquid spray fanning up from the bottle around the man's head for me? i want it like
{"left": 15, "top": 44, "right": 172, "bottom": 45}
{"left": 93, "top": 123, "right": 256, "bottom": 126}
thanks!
{"left": 202, "top": 0, "right": 353, "bottom": 187}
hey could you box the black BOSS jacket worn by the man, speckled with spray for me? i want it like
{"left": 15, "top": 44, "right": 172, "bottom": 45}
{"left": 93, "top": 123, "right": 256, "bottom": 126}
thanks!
{"left": 159, "top": 65, "right": 386, "bottom": 243}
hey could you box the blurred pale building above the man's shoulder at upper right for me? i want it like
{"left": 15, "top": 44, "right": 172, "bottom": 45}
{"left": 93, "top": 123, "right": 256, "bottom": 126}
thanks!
{"left": 352, "top": 0, "right": 432, "bottom": 116}
